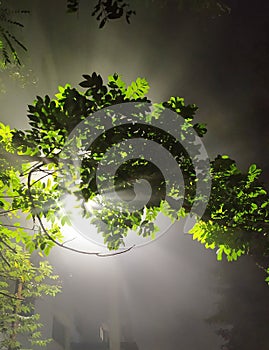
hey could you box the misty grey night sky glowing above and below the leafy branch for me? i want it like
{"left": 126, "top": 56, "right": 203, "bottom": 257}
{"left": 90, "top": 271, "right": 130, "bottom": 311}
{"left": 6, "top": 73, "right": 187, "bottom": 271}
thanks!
{"left": 0, "top": 0, "right": 269, "bottom": 350}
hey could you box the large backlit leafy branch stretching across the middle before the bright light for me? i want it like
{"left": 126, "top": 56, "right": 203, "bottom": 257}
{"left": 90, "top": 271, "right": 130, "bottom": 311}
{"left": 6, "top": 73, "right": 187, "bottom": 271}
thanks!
{"left": 0, "top": 73, "right": 269, "bottom": 272}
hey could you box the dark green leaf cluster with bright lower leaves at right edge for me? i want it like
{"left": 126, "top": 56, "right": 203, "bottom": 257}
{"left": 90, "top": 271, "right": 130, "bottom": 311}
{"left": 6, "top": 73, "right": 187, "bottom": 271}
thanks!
{"left": 190, "top": 155, "right": 269, "bottom": 261}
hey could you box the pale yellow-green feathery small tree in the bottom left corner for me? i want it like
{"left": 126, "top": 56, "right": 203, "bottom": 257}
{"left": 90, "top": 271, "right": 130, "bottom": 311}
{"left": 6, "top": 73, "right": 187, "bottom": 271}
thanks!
{"left": 0, "top": 241, "right": 60, "bottom": 350}
